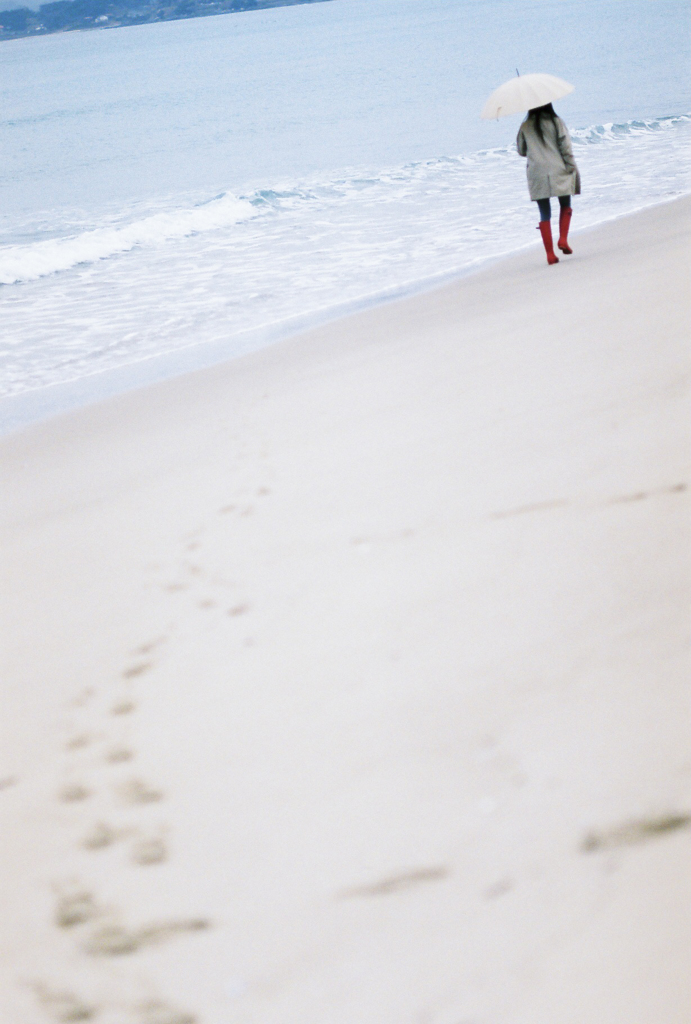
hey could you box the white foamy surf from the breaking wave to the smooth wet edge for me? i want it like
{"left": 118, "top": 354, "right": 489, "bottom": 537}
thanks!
{"left": 0, "top": 108, "right": 691, "bottom": 403}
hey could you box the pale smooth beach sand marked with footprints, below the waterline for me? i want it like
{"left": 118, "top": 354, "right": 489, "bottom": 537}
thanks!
{"left": 0, "top": 200, "right": 691, "bottom": 1024}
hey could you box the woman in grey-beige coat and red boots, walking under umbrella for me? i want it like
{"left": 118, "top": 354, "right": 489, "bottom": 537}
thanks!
{"left": 516, "top": 103, "right": 580, "bottom": 263}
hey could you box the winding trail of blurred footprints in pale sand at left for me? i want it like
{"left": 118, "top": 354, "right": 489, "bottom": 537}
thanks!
{"left": 33, "top": 486, "right": 271, "bottom": 1024}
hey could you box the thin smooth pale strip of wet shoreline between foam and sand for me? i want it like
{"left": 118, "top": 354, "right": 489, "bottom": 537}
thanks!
{"left": 0, "top": 195, "right": 688, "bottom": 437}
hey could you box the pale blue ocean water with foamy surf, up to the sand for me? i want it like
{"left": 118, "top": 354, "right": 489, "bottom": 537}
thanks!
{"left": 0, "top": 0, "right": 691, "bottom": 429}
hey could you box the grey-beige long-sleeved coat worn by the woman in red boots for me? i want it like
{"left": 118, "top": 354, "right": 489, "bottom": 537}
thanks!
{"left": 516, "top": 118, "right": 580, "bottom": 200}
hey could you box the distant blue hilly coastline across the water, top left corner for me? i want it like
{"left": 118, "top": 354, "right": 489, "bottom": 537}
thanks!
{"left": 0, "top": 0, "right": 329, "bottom": 41}
